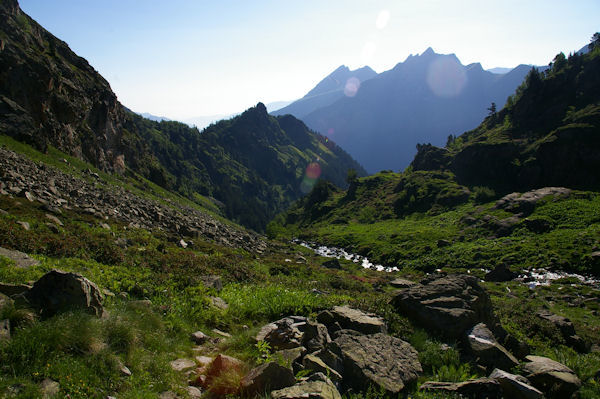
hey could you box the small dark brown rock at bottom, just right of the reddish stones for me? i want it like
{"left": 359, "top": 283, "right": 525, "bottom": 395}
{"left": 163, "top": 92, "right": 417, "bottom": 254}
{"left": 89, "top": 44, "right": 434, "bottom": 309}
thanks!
{"left": 241, "top": 362, "right": 296, "bottom": 395}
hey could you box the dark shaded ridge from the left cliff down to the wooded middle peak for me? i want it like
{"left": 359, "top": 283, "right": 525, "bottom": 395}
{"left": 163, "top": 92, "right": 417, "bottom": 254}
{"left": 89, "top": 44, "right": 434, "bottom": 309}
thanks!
{"left": 0, "top": 0, "right": 365, "bottom": 230}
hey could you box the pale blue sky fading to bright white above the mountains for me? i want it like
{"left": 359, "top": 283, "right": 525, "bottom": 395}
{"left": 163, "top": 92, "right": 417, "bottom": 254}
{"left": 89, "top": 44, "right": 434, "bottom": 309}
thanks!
{"left": 19, "top": 0, "right": 600, "bottom": 120}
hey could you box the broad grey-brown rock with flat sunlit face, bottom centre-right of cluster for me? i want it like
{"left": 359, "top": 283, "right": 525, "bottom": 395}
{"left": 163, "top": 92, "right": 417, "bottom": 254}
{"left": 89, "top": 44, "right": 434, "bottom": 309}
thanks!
{"left": 329, "top": 333, "right": 423, "bottom": 395}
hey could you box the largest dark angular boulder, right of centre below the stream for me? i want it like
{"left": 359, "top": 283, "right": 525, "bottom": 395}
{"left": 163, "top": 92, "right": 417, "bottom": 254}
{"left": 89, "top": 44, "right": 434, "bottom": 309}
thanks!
{"left": 392, "top": 274, "right": 504, "bottom": 339}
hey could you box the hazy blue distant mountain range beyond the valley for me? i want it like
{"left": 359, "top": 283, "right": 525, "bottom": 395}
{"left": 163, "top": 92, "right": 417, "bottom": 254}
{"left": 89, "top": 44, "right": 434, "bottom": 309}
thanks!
{"left": 273, "top": 48, "right": 545, "bottom": 173}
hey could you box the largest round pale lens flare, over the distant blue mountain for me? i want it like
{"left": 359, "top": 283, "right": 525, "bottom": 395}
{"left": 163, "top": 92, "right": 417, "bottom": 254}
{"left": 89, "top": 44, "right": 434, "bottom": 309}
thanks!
{"left": 427, "top": 57, "right": 467, "bottom": 98}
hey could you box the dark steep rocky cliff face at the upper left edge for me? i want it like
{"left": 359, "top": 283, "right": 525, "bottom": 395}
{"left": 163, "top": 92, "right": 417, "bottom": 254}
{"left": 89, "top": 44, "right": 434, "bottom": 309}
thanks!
{"left": 0, "top": 0, "right": 131, "bottom": 170}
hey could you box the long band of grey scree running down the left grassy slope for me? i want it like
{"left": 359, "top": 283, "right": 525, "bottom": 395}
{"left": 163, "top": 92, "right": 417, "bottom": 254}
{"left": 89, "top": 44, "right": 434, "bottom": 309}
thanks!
{"left": 0, "top": 148, "right": 266, "bottom": 253}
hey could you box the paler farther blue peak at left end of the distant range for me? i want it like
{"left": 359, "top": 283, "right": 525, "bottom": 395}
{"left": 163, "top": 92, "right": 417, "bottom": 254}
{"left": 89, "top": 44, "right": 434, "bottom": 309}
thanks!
{"left": 272, "top": 65, "right": 377, "bottom": 119}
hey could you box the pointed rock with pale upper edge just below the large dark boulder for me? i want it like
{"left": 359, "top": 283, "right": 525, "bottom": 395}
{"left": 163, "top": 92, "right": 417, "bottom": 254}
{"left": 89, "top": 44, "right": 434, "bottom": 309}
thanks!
{"left": 466, "top": 323, "right": 519, "bottom": 370}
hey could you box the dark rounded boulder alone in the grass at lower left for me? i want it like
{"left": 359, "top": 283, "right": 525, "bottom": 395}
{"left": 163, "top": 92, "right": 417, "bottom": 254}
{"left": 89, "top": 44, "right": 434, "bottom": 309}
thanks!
{"left": 25, "top": 270, "right": 104, "bottom": 317}
